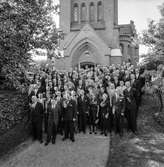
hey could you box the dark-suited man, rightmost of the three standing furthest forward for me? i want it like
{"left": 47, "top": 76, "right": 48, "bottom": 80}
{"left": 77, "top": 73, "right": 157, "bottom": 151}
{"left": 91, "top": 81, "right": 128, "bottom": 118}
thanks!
{"left": 63, "top": 92, "right": 76, "bottom": 142}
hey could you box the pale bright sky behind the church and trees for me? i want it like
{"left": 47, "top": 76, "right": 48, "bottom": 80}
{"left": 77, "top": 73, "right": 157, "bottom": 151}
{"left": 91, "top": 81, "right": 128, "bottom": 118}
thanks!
{"left": 55, "top": 0, "right": 164, "bottom": 55}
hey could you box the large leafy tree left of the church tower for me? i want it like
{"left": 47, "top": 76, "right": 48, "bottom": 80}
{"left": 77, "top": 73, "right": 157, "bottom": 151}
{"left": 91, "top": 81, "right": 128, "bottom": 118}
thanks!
{"left": 0, "top": 0, "right": 58, "bottom": 87}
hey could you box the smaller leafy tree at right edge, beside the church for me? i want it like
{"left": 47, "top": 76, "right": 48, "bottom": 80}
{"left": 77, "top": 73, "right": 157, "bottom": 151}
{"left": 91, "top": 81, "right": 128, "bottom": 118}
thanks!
{"left": 141, "top": 3, "right": 164, "bottom": 65}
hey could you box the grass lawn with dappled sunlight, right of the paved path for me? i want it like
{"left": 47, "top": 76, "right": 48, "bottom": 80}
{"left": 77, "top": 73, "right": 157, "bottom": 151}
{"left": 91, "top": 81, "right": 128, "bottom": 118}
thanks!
{"left": 106, "top": 97, "right": 164, "bottom": 167}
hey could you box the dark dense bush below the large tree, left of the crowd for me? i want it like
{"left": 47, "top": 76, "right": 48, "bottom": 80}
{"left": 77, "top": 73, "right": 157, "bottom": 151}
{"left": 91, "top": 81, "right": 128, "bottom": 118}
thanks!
{"left": 0, "top": 91, "right": 28, "bottom": 134}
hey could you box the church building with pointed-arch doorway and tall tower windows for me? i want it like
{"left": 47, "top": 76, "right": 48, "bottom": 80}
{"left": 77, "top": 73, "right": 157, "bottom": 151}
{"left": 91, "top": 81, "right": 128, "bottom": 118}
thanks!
{"left": 55, "top": 0, "right": 139, "bottom": 70}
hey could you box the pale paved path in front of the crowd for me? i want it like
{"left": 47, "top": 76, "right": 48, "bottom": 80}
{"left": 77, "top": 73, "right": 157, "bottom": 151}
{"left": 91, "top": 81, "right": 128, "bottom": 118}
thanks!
{"left": 0, "top": 134, "right": 109, "bottom": 167}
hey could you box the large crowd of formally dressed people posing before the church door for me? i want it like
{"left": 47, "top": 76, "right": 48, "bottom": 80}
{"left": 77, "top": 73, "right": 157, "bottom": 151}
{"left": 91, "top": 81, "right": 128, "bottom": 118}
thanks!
{"left": 28, "top": 63, "right": 145, "bottom": 145}
